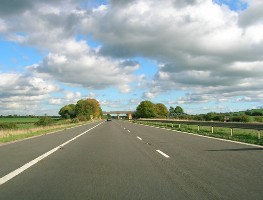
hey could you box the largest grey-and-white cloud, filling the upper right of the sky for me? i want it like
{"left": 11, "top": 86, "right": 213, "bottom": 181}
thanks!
{"left": 87, "top": 0, "right": 263, "bottom": 101}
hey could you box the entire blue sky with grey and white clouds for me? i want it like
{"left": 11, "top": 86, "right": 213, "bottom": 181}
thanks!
{"left": 0, "top": 0, "right": 263, "bottom": 115}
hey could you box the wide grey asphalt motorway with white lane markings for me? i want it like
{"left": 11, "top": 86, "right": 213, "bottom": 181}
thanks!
{"left": 0, "top": 120, "right": 263, "bottom": 200}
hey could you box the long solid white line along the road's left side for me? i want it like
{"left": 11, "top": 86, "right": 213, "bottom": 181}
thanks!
{"left": 0, "top": 122, "right": 104, "bottom": 186}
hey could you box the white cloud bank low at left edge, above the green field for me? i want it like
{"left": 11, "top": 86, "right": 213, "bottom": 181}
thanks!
{"left": 0, "top": 73, "right": 60, "bottom": 114}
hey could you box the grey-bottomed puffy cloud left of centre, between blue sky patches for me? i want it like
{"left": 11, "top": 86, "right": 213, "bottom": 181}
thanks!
{"left": 28, "top": 44, "right": 138, "bottom": 92}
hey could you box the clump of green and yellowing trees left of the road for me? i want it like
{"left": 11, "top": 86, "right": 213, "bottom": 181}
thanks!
{"left": 59, "top": 98, "right": 103, "bottom": 121}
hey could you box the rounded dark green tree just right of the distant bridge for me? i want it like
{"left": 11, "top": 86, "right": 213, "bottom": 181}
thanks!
{"left": 136, "top": 101, "right": 157, "bottom": 118}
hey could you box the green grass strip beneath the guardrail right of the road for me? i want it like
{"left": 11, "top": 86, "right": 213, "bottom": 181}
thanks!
{"left": 135, "top": 121, "right": 263, "bottom": 145}
